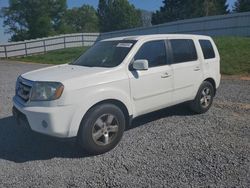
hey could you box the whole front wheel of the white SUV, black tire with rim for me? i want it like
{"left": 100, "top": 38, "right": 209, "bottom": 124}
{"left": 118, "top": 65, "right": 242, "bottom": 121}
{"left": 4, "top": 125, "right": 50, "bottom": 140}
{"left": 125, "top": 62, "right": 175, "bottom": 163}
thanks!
{"left": 78, "top": 104, "right": 126, "bottom": 154}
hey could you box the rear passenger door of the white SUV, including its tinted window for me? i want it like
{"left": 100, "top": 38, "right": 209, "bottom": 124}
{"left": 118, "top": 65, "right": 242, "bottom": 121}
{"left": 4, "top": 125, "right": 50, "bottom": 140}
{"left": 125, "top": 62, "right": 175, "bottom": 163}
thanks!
{"left": 168, "top": 39, "right": 202, "bottom": 103}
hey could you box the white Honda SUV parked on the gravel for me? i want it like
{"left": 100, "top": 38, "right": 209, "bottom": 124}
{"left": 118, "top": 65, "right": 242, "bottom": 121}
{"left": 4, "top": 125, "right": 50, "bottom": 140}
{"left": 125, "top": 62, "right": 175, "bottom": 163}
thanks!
{"left": 13, "top": 35, "right": 220, "bottom": 153}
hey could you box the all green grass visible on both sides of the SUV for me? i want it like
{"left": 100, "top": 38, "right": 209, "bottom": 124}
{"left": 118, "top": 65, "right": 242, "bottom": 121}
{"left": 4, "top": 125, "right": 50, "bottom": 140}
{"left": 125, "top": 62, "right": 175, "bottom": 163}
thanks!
{"left": 14, "top": 37, "right": 250, "bottom": 75}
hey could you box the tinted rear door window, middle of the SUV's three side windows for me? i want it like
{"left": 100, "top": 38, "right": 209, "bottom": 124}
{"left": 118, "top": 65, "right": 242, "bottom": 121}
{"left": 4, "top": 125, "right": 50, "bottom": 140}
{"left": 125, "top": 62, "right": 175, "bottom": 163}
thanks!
{"left": 170, "top": 39, "right": 197, "bottom": 63}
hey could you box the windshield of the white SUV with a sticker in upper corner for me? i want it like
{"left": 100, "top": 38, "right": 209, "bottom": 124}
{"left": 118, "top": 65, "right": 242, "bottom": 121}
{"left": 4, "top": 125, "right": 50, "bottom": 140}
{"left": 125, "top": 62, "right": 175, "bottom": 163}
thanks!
{"left": 72, "top": 40, "right": 136, "bottom": 67}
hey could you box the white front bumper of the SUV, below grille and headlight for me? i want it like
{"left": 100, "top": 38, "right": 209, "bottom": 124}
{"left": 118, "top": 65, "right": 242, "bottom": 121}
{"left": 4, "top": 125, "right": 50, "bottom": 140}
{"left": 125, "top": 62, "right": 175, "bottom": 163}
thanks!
{"left": 13, "top": 97, "right": 74, "bottom": 138}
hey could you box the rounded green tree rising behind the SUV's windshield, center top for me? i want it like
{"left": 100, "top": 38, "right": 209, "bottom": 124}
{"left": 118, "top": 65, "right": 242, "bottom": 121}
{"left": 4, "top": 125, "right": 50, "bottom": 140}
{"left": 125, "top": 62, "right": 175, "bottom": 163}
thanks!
{"left": 98, "top": 0, "right": 142, "bottom": 32}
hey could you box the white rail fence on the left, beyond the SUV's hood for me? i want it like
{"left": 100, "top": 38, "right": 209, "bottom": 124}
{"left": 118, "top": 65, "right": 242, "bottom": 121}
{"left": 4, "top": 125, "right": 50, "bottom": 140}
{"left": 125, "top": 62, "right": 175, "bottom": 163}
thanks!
{"left": 0, "top": 33, "right": 99, "bottom": 58}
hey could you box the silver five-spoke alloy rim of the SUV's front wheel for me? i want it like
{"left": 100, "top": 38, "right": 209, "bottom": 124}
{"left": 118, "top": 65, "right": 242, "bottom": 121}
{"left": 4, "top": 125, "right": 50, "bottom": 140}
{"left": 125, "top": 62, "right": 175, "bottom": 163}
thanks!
{"left": 92, "top": 114, "right": 119, "bottom": 146}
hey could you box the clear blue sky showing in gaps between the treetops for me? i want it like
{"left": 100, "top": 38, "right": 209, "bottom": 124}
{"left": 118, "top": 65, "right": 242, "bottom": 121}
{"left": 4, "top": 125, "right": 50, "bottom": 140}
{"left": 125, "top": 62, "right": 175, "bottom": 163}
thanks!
{"left": 0, "top": 0, "right": 235, "bottom": 43}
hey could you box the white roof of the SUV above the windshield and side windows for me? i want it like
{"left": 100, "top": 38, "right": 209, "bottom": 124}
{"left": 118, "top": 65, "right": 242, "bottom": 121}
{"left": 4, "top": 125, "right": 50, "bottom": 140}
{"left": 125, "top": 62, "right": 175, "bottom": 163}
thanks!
{"left": 102, "top": 34, "right": 210, "bottom": 41}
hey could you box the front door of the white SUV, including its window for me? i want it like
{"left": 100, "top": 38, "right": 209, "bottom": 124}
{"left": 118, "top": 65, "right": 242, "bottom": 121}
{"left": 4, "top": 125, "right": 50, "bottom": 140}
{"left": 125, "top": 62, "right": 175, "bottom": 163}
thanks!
{"left": 129, "top": 40, "right": 173, "bottom": 115}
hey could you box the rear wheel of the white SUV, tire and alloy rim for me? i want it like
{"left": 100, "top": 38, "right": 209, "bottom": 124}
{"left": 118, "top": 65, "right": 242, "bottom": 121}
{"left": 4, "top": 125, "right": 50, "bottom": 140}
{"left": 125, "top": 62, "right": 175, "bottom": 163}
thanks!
{"left": 190, "top": 81, "right": 215, "bottom": 114}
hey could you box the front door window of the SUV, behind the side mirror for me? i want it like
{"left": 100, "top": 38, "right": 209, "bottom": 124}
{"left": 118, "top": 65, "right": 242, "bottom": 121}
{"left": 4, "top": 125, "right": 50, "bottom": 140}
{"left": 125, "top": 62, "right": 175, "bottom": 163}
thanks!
{"left": 134, "top": 40, "right": 167, "bottom": 67}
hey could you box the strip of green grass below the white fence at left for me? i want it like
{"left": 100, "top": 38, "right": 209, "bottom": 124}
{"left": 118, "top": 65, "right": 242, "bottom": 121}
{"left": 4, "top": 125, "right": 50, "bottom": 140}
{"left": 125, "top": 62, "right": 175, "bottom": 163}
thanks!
{"left": 12, "top": 47, "right": 88, "bottom": 65}
